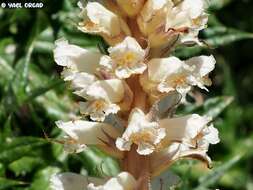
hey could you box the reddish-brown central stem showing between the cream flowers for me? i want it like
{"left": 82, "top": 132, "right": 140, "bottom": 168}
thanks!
{"left": 120, "top": 18, "right": 150, "bottom": 190}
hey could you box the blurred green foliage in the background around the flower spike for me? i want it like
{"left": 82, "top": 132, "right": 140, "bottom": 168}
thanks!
{"left": 0, "top": 0, "right": 253, "bottom": 190}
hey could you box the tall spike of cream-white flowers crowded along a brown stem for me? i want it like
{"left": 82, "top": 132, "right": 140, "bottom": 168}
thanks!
{"left": 51, "top": 0, "right": 219, "bottom": 190}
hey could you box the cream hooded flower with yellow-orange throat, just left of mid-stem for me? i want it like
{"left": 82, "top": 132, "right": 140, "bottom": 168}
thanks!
{"left": 76, "top": 79, "right": 124, "bottom": 121}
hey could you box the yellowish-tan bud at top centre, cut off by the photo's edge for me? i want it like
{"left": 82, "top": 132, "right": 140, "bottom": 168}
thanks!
{"left": 117, "top": 0, "right": 145, "bottom": 17}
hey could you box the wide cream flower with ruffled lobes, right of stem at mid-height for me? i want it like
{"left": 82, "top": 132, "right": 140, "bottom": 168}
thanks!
{"left": 140, "top": 56, "right": 215, "bottom": 97}
